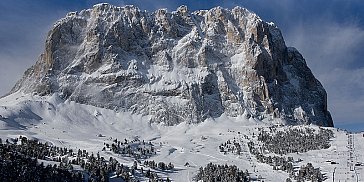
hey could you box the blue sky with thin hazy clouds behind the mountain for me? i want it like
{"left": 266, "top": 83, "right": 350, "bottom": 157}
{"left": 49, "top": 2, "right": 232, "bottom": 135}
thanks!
{"left": 0, "top": 0, "right": 364, "bottom": 131}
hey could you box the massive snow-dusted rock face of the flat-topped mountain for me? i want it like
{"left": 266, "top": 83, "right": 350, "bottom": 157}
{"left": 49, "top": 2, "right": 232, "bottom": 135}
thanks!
{"left": 12, "top": 4, "right": 333, "bottom": 126}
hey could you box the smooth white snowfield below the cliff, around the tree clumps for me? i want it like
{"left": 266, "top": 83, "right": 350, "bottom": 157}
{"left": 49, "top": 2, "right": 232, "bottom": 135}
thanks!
{"left": 0, "top": 93, "right": 364, "bottom": 182}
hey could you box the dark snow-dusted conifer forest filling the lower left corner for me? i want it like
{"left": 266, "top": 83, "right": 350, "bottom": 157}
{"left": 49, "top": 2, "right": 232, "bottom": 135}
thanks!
{"left": 0, "top": 136, "right": 174, "bottom": 182}
